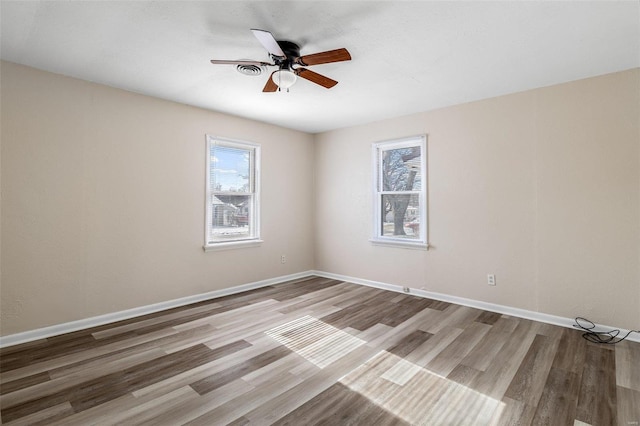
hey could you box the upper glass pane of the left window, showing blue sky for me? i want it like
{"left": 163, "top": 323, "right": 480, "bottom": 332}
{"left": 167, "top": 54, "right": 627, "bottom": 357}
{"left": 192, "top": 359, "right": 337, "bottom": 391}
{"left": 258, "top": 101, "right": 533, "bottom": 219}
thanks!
{"left": 209, "top": 144, "right": 252, "bottom": 192}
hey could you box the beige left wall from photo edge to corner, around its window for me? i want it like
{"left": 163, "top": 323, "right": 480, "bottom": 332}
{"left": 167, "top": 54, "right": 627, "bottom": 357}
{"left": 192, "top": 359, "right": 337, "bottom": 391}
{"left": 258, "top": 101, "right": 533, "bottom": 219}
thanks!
{"left": 0, "top": 62, "right": 314, "bottom": 335}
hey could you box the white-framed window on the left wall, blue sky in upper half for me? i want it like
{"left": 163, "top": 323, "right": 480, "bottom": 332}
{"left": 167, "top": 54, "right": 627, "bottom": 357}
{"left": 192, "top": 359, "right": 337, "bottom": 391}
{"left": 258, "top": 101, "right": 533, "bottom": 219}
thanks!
{"left": 204, "top": 135, "right": 262, "bottom": 250}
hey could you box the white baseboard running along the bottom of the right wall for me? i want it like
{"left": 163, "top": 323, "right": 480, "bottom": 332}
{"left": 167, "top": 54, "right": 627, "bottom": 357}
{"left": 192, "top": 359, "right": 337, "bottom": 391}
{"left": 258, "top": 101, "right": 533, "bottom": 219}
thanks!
{"left": 312, "top": 271, "right": 640, "bottom": 343}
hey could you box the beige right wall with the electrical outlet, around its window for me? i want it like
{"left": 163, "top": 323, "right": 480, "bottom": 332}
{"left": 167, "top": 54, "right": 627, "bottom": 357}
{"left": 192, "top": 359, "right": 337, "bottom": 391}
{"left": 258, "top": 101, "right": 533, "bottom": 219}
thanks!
{"left": 315, "top": 69, "right": 640, "bottom": 329}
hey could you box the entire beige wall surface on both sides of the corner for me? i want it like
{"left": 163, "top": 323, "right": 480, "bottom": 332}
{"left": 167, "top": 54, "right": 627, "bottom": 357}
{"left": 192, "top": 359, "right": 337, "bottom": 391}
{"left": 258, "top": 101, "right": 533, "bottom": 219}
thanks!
{"left": 0, "top": 62, "right": 640, "bottom": 335}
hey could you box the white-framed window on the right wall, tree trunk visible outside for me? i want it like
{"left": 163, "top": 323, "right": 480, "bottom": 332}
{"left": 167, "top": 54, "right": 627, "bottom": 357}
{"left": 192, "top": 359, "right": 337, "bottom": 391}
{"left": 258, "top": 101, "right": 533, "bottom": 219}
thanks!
{"left": 371, "top": 136, "right": 428, "bottom": 248}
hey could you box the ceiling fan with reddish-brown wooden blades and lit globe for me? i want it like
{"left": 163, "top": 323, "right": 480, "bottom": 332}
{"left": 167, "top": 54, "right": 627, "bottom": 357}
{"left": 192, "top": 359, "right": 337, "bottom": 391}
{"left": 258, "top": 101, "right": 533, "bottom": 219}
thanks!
{"left": 211, "top": 29, "right": 351, "bottom": 92}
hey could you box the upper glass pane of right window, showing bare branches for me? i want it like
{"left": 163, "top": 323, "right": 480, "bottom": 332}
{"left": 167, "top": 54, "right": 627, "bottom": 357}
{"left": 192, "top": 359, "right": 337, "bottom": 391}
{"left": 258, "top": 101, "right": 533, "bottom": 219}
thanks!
{"left": 381, "top": 146, "right": 422, "bottom": 191}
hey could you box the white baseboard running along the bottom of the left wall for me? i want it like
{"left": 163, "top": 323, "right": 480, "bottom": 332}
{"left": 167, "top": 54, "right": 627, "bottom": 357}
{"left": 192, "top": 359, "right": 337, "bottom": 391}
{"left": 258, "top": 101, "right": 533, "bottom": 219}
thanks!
{"left": 0, "top": 271, "right": 313, "bottom": 348}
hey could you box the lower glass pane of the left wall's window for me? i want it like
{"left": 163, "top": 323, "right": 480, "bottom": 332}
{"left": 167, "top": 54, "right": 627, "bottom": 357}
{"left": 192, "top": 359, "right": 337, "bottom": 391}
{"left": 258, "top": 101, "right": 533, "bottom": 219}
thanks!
{"left": 209, "top": 194, "right": 253, "bottom": 241}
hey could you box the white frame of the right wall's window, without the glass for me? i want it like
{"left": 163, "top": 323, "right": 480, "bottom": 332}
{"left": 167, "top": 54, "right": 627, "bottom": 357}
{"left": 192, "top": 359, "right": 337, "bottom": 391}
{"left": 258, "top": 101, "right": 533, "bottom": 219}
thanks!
{"left": 370, "top": 135, "right": 429, "bottom": 250}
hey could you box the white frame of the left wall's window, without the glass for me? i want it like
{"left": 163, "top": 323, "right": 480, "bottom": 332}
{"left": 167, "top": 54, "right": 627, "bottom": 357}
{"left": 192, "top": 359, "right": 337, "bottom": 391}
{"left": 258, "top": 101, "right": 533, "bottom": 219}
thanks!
{"left": 203, "top": 135, "right": 263, "bottom": 251}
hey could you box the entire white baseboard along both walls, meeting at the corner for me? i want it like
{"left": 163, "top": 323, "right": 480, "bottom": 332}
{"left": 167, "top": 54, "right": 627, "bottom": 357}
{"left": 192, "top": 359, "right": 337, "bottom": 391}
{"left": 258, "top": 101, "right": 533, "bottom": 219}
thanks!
{"left": 0, "top": 271, "right": 640, "bottom": 348}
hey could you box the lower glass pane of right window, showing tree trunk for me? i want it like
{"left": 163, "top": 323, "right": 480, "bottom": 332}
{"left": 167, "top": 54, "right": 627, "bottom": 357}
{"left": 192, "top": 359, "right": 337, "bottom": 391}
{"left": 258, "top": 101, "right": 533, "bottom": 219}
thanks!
{"left": 380, "top": 194, "right": 420, "bottom": 239}
